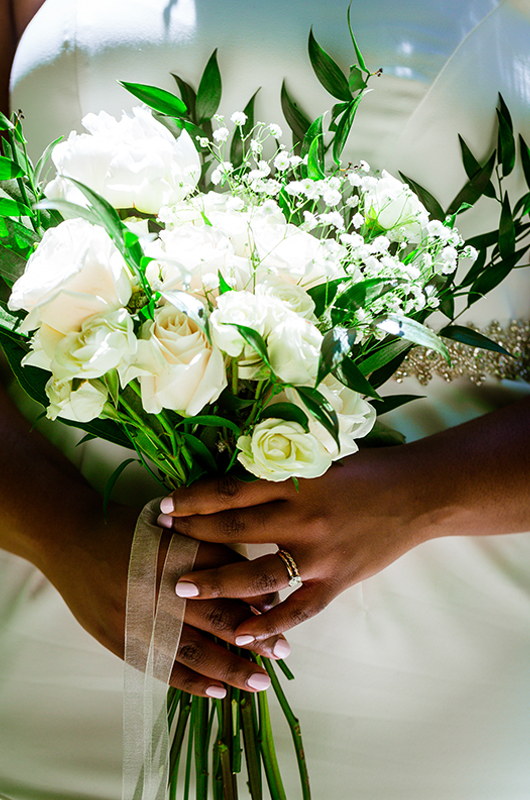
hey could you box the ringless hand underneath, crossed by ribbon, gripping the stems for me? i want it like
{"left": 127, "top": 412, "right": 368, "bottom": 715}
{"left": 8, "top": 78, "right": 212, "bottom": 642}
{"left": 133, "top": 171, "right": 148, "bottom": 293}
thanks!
{"left": 42, "top": 506, "right": 289, "bottom": 697}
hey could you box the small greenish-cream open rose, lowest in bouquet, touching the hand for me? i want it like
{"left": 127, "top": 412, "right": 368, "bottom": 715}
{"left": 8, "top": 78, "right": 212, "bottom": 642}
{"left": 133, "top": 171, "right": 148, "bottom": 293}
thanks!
{"left": 237, "top": 419, "right": 331, "bottom": 481}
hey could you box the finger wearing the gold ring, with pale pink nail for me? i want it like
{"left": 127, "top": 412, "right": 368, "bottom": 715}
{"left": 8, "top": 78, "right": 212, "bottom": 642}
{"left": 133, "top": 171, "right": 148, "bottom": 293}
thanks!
{"left": 175, "top": 553, "right": 290, "bottom": 600}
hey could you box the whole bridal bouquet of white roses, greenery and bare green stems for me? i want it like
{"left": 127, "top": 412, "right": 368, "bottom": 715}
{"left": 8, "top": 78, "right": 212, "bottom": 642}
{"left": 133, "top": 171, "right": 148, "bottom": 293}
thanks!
{"left": 0, "top": 10, "right": 530, "bottom": 798}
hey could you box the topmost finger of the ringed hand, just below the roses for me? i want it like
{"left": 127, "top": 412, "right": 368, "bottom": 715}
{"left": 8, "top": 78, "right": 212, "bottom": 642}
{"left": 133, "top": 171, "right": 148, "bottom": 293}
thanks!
{"left": 160, "top": 475, "right": 293, "bottom": 517}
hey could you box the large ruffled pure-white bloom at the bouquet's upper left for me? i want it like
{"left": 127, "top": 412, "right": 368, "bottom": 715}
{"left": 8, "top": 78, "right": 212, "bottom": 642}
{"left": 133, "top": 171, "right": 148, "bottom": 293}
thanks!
{"left": 46, "top": 107, "right": 200, "bottom": 214}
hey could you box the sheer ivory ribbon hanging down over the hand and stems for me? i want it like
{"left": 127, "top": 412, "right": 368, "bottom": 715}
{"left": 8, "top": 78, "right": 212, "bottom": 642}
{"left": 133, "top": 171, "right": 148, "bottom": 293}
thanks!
{"left": 122, "top": 498, "right": 199, "bottom": 800}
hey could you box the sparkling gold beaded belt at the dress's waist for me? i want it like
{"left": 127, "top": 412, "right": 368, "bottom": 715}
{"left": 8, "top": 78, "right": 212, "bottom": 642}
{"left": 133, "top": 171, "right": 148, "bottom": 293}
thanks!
{"left": 394, "top": 320, "right": 530, "bottom": 386}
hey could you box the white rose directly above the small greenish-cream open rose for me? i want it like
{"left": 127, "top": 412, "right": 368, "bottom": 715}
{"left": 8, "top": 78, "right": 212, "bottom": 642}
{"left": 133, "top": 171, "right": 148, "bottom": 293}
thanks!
{"left": 267, "top": 314, "right": 323, "bottom": 386}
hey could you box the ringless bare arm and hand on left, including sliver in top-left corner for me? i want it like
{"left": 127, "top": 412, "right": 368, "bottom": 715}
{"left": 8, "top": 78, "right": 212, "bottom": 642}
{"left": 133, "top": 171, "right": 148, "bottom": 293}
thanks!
{"left": 0, "top": 0, "right": 289, "bottom": 696}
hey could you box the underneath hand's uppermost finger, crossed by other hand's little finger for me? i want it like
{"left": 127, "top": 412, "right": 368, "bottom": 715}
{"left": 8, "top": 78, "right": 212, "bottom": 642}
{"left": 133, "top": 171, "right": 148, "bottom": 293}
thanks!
{"left": 185, "top": 600, "right": 291, "bottom": 659}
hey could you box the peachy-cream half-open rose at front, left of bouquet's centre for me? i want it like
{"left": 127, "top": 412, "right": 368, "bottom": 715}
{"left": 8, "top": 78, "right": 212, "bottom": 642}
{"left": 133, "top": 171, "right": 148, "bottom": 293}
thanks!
{"left": 135, "top": 305, "right": 226, "bottom": 416}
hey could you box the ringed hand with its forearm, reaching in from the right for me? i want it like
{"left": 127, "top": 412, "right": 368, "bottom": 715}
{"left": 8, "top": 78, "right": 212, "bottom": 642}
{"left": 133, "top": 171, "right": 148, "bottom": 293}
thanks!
{"left": 159, "top": 399, "right": 530, "bottom": 646}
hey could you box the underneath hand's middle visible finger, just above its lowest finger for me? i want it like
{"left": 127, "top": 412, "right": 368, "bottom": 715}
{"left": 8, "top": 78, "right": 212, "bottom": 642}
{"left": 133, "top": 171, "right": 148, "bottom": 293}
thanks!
{"left": 176, "top": 625, "right": 270, "bottom": 692}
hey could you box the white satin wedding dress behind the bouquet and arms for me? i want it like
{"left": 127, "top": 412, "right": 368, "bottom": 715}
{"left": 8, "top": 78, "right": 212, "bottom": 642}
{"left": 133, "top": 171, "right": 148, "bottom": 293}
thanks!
{"left": 0, "top": 0, "right": 530, "bottom": 800}
